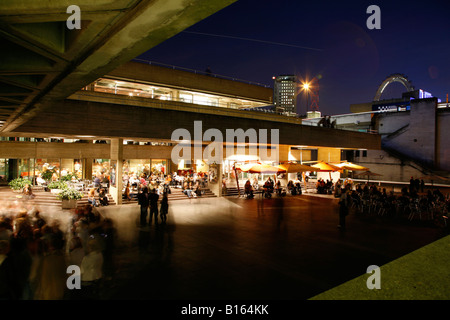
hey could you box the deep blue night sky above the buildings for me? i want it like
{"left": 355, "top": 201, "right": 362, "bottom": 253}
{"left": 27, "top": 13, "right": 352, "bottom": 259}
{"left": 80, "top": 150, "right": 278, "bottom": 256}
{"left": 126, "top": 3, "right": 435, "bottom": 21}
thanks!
{"left": 138, "top": 0, "right": 450, "bottom": 115}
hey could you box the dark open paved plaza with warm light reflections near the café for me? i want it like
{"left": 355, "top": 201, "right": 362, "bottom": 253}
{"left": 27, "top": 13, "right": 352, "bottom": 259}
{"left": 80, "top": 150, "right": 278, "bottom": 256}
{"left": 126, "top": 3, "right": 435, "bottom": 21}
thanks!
{"left": 84, "top": 194, "right": 445, "bottom": 300}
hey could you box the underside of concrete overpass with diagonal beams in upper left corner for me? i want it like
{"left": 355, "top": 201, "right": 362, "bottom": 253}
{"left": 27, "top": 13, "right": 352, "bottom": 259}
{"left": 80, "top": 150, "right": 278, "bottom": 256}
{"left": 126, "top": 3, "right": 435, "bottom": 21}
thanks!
{"left": 0, "top": 0, "right": 235, "bottom": 133}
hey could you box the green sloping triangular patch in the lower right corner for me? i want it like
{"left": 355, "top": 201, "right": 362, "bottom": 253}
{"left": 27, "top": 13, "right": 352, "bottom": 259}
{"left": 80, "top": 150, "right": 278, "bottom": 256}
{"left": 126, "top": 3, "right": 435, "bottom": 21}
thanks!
{"left": 310, "top": 236, "right": 450, "bottom": 300}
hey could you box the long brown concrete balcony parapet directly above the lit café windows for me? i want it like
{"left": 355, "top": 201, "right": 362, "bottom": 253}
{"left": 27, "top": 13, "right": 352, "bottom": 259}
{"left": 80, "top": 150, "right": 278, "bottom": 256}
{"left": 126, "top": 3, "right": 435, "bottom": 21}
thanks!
{"left": 7, "top": 91, "right": 380, "bottom": 149}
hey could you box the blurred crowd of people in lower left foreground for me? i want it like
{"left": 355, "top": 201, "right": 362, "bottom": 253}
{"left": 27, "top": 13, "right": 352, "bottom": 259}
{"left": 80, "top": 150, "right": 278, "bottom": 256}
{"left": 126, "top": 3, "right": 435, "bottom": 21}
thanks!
{"left": 0, "top": 202, "right": 115, "bottom": 300}
